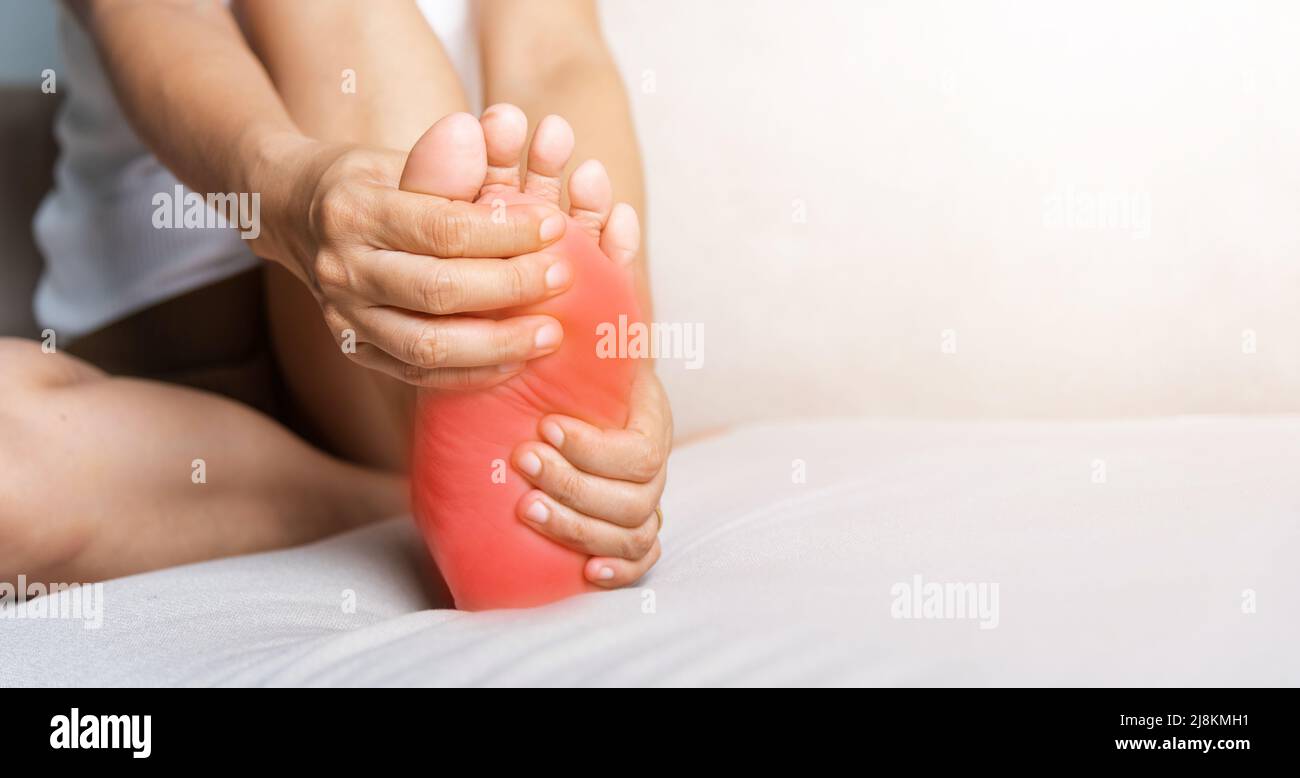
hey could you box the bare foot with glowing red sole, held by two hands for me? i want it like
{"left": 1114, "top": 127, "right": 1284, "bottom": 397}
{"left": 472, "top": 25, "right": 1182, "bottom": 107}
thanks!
{"left": 400, "top": 105, "right": 640, "bottom": 610}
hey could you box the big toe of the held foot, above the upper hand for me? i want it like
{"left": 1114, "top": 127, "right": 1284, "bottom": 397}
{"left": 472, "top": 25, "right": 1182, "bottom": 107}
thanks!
{"left": 399, "top": 113, "right": 488, "bottom": 200}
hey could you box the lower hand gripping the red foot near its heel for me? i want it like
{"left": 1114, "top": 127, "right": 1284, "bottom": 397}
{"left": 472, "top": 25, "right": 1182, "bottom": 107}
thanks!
{"left": 515, "top": 363, "right": 672, "bottom": 588}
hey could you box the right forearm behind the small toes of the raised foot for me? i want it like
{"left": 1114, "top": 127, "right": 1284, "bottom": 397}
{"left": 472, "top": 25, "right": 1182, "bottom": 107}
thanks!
{"left": 481, "top": 0, "right": 651, "bottom": 317}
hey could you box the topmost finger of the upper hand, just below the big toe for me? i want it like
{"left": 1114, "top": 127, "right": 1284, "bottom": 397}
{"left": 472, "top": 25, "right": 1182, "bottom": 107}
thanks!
{"left": 369, "top": 189, "right": 567, "bottom": 258}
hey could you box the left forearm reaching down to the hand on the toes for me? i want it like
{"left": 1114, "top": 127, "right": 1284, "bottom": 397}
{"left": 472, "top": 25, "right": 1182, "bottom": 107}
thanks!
{"left": 69, "top": 0, "right": 319, "bottom": 265}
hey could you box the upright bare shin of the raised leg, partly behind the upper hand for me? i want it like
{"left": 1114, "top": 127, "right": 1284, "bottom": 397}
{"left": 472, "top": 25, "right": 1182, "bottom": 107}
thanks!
{"left": 235, "top": 0, "right": 468, "bottom": 470}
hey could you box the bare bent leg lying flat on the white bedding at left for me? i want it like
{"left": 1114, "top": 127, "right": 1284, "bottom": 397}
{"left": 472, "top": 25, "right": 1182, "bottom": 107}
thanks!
{"left": 0, "top": 338, "right": 407, "bottom": 580}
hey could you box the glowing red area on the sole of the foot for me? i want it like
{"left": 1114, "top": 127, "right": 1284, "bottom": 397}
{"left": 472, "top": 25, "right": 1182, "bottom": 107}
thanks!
{"left": 411, "top": 193, "right": 641, "bottom": 610}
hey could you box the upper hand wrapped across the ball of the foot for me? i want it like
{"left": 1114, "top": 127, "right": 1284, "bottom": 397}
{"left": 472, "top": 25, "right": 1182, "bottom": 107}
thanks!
{"left": 257, "top": 142, "right": 572, "bottom": 389}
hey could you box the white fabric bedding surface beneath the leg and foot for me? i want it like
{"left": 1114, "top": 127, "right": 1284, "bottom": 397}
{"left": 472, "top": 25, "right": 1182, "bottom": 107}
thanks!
{"left": 0, "top": 416, "right": 1300, "bottom": 686}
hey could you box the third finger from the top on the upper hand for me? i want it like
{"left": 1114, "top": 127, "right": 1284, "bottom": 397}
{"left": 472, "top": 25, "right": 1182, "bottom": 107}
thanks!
{"left": 354, "top": 307, "right": 564, "bottom": 369}
